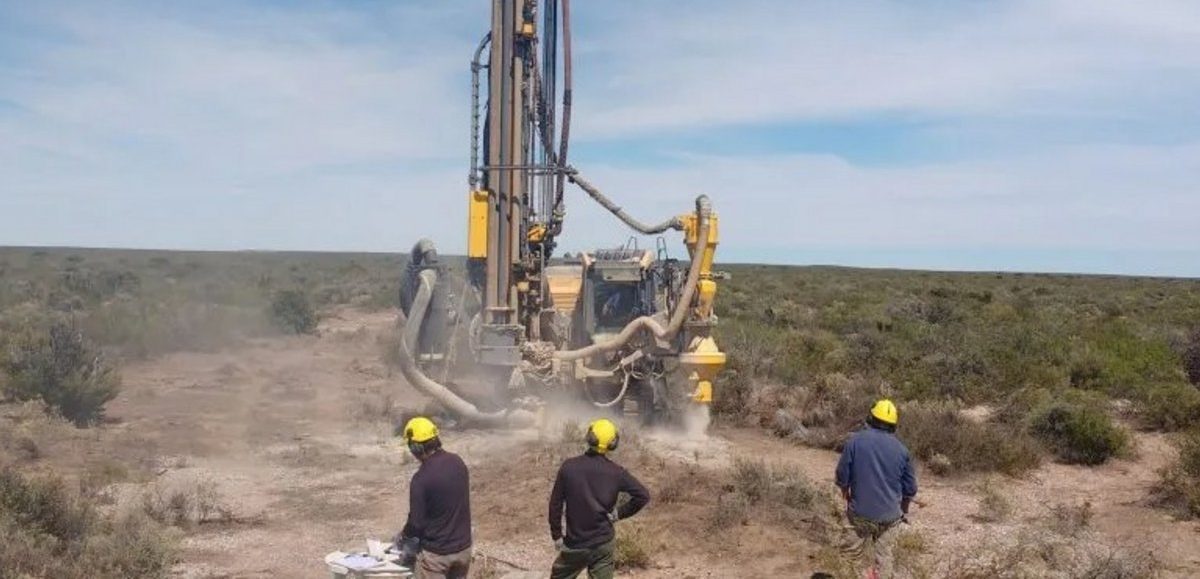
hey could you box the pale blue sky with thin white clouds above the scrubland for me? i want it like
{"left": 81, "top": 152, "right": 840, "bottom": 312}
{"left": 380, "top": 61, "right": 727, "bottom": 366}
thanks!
{"left": 0, "top": 0, "right": 1200, "bottom": 276}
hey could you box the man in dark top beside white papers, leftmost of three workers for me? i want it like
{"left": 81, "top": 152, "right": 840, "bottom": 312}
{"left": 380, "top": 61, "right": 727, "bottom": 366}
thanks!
{"left": 396, "top": 417, "right": 472, "bottom": 579}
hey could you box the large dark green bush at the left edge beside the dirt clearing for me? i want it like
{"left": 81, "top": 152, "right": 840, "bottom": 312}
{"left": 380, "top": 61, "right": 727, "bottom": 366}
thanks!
{"left": 0, "top": 321, "right": 120, "bottom": 426}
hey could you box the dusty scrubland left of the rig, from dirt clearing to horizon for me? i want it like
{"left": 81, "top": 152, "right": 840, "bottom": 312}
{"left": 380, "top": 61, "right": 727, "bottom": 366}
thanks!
{"left": 0, "top": 249, "right": 401, "bottom": 426}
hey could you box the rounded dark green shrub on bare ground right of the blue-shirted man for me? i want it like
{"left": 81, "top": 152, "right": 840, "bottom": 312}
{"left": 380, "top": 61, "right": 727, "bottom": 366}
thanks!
{"left": 1030, "top": 399, "right": 1129, "bottom": 465}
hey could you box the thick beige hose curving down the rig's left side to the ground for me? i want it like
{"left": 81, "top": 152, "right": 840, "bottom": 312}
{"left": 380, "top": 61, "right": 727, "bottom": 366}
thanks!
{"left": 400, "top": 269, "right": 534, "bottom": 426}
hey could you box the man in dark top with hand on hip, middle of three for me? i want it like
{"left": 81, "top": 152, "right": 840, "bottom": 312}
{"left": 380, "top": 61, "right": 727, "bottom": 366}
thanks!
{"left": 550, "top": 418, "right": 650, "bottom": 579}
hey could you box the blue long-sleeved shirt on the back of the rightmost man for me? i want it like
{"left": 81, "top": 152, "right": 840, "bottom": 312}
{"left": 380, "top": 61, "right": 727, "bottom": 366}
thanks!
{"left": 838, "top": 426, "right": 917, "bottom": 523}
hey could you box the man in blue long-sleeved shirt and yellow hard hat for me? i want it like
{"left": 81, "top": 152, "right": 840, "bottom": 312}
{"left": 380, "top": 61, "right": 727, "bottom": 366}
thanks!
{"left": 836, "top": 400, "right": 917, "bottom": 579}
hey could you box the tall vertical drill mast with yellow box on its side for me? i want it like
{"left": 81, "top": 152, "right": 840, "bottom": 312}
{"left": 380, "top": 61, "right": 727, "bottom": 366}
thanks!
{"left": 468, "top": 0, "right": 570, "bottom": 366}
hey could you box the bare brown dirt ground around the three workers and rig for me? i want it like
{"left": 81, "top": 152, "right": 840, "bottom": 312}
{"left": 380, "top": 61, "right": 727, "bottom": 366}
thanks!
{"left": 35, "top": 305, "right": 1200, "bottom": 578}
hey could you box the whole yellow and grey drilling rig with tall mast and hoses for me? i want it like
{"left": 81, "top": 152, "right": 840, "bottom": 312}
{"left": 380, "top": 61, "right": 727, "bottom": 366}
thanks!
{"left": 398, "top": 0, "right": 725, "bottom": 425}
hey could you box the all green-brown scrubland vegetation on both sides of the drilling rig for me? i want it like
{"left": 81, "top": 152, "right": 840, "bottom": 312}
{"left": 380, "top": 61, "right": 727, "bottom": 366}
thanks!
{"left": 0, "top": 249, "right": 1200, "bottom": 577}
